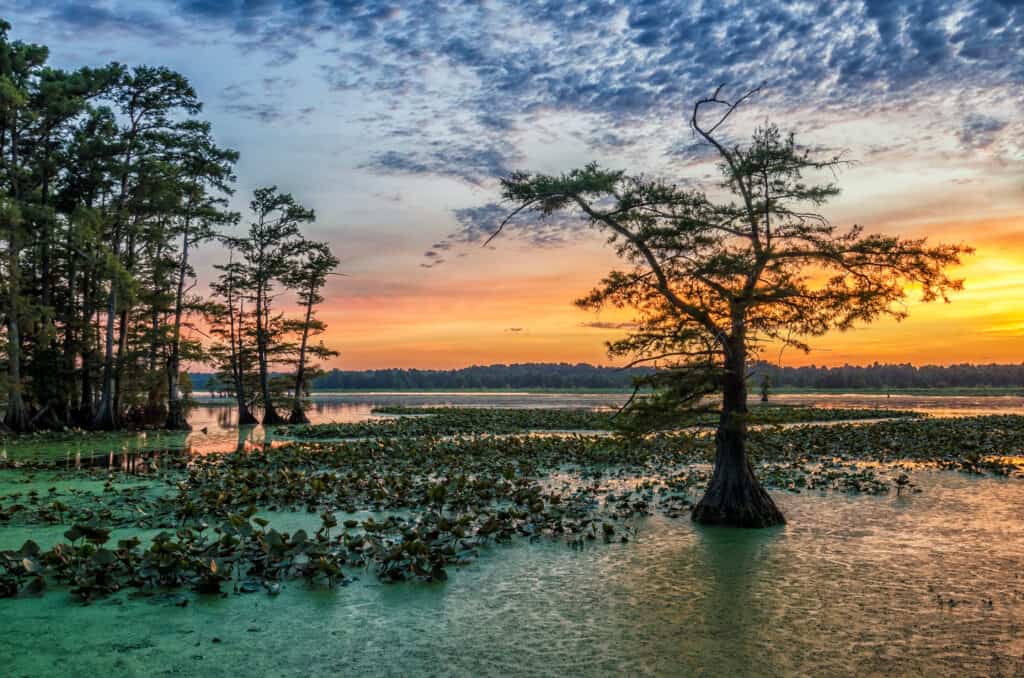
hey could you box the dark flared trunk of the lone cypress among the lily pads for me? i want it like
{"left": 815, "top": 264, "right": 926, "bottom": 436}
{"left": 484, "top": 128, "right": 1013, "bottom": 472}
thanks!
{"left": 690, "top": 328, "right": 785, "bottom": 527}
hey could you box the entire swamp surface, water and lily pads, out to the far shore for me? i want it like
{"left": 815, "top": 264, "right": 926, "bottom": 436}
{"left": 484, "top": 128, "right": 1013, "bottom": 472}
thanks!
{"left": 0, "top": 393, "right": 1024, "bottom": 676}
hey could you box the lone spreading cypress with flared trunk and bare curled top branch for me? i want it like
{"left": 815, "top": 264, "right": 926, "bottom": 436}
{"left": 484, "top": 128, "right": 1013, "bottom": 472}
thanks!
{"left": 488, "top": 88, "right": 970, "bottom": 527}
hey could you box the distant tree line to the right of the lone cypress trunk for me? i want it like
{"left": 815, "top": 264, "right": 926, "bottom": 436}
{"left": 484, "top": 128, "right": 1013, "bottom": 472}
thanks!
{"left": 754, "top": 363, "right": 1024, "bottom": 388}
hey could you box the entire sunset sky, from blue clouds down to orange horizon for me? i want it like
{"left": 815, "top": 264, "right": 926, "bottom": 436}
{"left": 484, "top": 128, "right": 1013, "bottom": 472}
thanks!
{"left": 0, "top": 0, "right": 1024, "bottom": 370}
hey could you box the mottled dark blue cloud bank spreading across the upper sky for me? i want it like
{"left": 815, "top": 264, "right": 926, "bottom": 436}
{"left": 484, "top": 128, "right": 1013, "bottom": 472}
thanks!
{"left": 11, "top": 0, "right": 1024, "bottom": 199}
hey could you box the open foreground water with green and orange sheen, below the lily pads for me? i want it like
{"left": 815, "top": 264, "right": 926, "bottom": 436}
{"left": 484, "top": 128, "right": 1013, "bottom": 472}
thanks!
{"left": 0, "top": 472, "right": 1024, "bottom": 676}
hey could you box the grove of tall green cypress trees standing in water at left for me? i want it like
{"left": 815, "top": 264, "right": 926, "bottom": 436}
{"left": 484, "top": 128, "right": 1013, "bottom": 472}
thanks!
{"left": 0, "top": 25, "right": 338, "bottom": 432}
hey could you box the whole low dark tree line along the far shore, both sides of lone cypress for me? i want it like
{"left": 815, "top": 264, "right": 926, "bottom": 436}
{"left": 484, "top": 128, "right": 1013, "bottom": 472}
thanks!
{"left": 190, "top": 363, "right": 1024, "bottom": 392}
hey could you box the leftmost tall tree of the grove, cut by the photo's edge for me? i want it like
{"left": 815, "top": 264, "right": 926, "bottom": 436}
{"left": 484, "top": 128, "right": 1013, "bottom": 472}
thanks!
{"left": 0, "top": 19, "right": 122, "bottom": 431}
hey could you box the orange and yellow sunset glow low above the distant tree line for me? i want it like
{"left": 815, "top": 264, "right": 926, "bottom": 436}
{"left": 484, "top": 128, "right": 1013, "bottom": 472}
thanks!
{"left": 190, "top": 218, "right": 1024, "bottom": 370}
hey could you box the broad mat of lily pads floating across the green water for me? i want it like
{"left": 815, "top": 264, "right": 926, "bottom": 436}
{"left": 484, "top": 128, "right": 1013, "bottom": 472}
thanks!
{"left": 0, "top": 410, "right": 1024, "bottom": 601}
